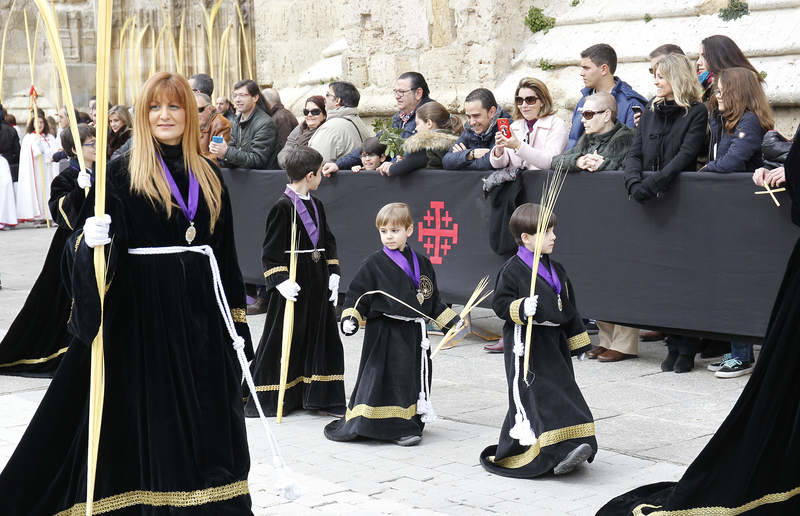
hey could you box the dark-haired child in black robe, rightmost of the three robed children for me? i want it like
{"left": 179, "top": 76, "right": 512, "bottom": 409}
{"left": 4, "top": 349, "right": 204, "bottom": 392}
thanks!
{"left": 481, "top": 203, "right": 597, "bottom": 478}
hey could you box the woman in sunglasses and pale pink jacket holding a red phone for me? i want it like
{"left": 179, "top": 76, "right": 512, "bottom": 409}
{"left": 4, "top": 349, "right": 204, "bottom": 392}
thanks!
{"left": 489, "top": 77, "right": 569, "bottom": 170}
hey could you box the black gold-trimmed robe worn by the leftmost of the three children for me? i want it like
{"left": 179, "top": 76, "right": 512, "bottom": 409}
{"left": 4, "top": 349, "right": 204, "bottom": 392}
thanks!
{"left": 245, "top": 191, "right": 345, "bottom": 417}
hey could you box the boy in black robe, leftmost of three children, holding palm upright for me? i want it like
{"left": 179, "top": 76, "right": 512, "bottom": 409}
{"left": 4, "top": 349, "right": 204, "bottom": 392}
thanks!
{"left": 244, "top": 143, "right": 345, "bottom": 417}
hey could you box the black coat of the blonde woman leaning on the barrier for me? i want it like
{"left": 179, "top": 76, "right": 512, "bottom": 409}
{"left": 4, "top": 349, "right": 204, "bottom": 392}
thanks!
{"left": 625, "top": 101, "right": 708, "bottom": 202}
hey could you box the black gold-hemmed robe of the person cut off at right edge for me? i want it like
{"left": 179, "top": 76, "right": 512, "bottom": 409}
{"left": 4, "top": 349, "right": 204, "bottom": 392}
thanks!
{"left": 597, "top": 129, "right": 800, "bottom": 516}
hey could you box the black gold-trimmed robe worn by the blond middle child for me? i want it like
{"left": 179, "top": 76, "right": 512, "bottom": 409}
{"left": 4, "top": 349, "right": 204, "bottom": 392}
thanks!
{"left": 325, "top": 246, "right": 459, "bottom": 441}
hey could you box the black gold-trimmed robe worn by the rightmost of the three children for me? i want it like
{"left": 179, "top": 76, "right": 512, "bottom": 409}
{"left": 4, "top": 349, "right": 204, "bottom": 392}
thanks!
{"left": 481, "top": 256, "right": 597, "bottom": 478}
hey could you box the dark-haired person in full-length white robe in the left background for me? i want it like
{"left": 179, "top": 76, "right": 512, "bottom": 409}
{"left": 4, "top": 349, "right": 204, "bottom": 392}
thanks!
{"left": 17, "top": 110, "right": 58, "bottom": 221}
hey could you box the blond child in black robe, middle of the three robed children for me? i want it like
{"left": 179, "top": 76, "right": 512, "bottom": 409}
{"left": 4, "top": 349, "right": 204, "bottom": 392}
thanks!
{"left": 325, "top": 203, "right": 460, "bottom": 446}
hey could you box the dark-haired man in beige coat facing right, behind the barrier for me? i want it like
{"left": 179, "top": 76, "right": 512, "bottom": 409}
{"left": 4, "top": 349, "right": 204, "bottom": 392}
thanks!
{"left": 308, "top": 81, "right": 372, "bottom": 163}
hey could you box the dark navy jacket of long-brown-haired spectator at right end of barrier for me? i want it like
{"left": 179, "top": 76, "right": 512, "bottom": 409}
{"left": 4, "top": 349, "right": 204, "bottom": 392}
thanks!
{"left": 702, "top": 111, "right": 766, "bottom": 172}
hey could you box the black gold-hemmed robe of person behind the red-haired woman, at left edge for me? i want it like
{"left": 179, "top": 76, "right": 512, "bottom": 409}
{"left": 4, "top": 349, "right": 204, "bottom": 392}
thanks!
{"left": 0, "top": 159, "right": 86, "bottom": 377}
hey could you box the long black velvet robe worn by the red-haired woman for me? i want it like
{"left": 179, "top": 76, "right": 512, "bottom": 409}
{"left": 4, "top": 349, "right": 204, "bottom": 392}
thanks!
{"left": 0, "top": 146, "right": 252, "bottom": 516}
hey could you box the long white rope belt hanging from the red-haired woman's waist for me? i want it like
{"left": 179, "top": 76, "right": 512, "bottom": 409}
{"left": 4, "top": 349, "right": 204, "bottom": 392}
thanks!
{"left": 128, "top": 245, "right": 298, "bottom": 499}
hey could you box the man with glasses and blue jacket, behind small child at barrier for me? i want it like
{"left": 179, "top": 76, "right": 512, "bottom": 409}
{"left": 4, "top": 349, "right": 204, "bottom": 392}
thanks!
{"left": 322, "top": 72, "right": 432, "bottom": 175}
